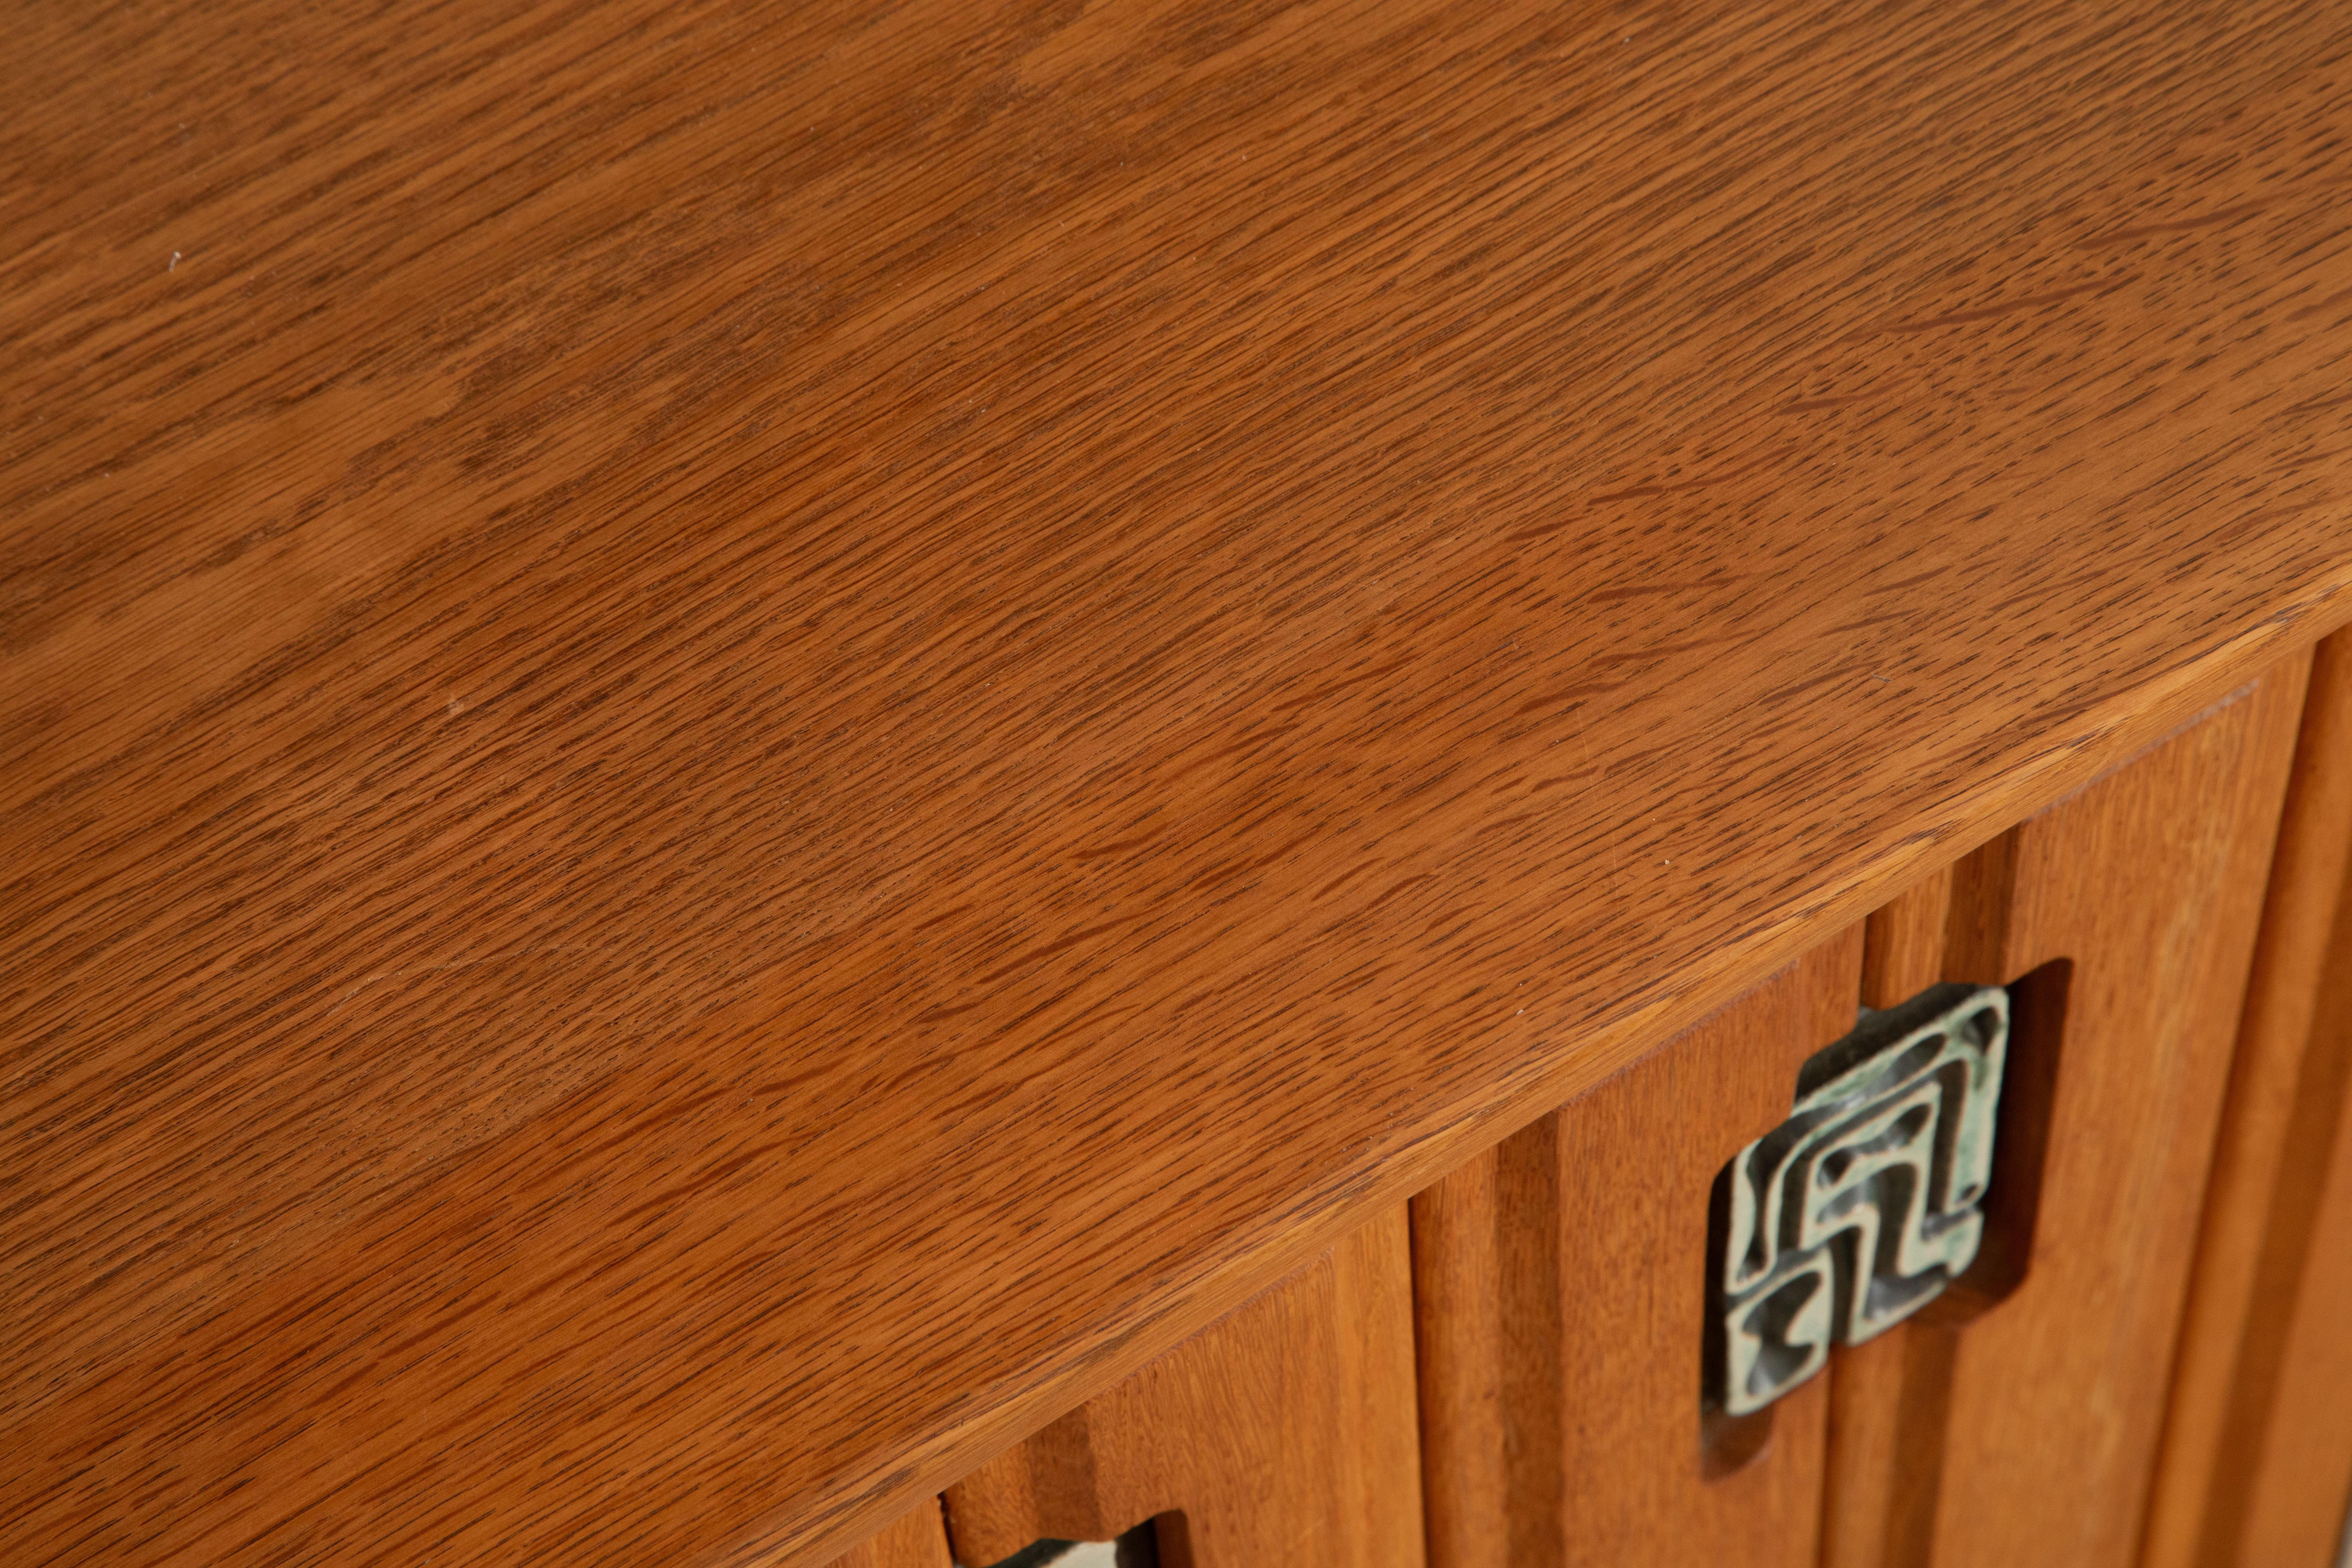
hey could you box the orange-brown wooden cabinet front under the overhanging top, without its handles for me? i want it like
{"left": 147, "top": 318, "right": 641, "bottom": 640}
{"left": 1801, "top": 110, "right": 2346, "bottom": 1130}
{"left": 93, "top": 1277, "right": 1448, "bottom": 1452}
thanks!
{"left": 823, "top": 639, "right": 2314, "bottom": 1568}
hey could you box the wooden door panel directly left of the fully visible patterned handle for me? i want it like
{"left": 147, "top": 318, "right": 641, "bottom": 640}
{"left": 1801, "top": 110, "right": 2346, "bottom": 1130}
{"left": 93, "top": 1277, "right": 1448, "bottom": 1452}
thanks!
{"left": 1414, "top": 929, "right": 1863, "bottom": 1568}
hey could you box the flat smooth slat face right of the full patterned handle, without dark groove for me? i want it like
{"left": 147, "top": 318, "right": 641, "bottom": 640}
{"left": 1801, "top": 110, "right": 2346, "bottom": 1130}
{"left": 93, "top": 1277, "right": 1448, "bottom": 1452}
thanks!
{"left": 1933, "top": 658, "right": 2307, "bottom": 1568}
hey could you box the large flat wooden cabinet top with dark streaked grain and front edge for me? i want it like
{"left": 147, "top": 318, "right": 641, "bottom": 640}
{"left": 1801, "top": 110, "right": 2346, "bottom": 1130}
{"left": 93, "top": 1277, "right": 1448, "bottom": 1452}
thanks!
{"left": 0, "top": 0, "right": 2352, "bottom": 1563}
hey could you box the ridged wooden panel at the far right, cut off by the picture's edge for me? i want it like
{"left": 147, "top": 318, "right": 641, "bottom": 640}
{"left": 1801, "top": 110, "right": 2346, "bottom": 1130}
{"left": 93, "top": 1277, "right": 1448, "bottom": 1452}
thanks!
{"left": 2143, "top": 632, "right": 2352, "bottom": 1568}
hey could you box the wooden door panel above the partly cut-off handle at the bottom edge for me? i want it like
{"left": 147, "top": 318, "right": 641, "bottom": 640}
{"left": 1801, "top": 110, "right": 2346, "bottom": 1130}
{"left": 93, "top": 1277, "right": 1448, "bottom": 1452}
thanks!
{"left": 948, "top": 1206, "right": 1423, "bottom": 1568}
